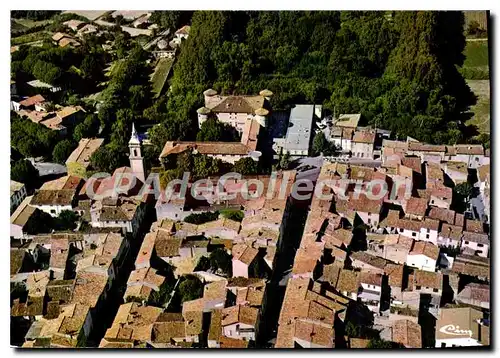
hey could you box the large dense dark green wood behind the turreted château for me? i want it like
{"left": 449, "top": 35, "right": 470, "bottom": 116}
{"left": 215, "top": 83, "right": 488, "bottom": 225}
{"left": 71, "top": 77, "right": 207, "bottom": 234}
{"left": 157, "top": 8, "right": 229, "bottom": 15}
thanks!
{"left": 151, "top": 11, "right": 475, "bottom": 143}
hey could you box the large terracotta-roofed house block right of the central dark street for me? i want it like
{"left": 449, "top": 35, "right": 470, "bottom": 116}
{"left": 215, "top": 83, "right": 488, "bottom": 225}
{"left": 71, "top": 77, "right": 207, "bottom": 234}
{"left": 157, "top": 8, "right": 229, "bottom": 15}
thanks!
{"left": 276, "top": 140, "right": 490, "bottom": 348}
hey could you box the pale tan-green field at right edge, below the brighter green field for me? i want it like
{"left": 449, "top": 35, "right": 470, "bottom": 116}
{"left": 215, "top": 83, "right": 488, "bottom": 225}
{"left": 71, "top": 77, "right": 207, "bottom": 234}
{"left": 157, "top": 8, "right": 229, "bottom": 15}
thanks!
{"left": 466, "top": 80, "right": 491, "bottom": 133}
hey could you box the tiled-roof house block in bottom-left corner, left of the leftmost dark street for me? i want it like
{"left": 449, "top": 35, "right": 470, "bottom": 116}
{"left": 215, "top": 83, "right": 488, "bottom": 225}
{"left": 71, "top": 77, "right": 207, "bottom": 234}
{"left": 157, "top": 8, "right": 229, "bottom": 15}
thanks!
{"left": 10, "top": 232, "right": 129, "bottom": 348}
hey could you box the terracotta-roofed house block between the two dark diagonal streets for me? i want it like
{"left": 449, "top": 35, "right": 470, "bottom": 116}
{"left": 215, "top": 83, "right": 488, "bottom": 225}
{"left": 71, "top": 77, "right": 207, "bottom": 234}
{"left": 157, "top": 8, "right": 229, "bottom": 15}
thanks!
{"left": 99, "top": 172, "right": 294, "bottom": 348}
